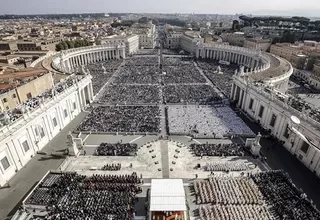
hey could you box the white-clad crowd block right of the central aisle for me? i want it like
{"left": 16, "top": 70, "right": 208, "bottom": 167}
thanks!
{"left": 167, "top": 105, "right": 254, "bottom": 137}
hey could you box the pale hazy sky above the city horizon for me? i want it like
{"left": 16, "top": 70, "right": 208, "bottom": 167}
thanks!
{"left": 0, "top": 0, "right": 320, "bottom": 16}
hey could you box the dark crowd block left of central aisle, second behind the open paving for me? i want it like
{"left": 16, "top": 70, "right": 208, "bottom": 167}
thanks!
{"left": 99, "top": 84, "right": 162, "bottom": 104}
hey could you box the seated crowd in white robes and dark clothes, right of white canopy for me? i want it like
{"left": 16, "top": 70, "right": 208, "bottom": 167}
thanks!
{"left": 194, "top": 171, "right": 320, "bottom": 220}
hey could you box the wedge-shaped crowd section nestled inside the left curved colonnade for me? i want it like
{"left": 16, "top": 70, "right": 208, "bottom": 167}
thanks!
{"left": 84, "top": 60, "right": 122, "bottom": 94}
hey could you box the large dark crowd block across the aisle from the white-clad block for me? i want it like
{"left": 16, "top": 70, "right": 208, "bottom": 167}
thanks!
{"left": 77, "top": 106, "right": 160, "bottom": 133}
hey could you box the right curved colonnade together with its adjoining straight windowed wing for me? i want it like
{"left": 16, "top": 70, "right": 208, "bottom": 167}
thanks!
{"left": 195, "top": 44, "right": 320, "bottom": 177}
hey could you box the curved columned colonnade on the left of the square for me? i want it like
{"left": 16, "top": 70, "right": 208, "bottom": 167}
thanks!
{"left": 52, "top": 44, "right": 126, "bottom": 74}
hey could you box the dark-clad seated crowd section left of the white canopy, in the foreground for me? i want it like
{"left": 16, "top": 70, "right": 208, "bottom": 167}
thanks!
{"left": 25, "top": 173, "right": 142, "bottom": 220}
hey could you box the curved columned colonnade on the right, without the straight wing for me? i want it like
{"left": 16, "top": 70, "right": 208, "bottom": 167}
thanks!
{"left": 196, "top": 44, "right": 293, "bottom": 92}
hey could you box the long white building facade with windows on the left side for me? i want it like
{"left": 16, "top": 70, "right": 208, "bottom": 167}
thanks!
{"left": 0, "top": 75, "right": 93, "bottom": 186}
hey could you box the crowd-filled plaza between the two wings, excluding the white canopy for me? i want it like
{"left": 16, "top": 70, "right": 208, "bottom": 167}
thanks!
{"left": 0, "top": 46, "right": 320, "bottom": 220}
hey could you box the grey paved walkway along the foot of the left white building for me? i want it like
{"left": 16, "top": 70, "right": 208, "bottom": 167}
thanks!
{"left": 0, "top": 113, "right": 86, "bottom": 220}
